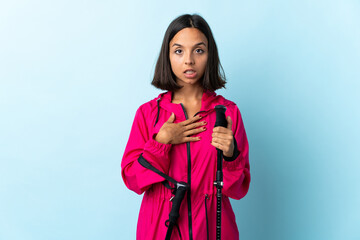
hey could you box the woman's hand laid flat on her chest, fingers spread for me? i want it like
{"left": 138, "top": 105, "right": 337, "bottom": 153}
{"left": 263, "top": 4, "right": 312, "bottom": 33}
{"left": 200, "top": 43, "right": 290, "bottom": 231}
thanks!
{"left": 155, "top": 113, "right": 206, "bottom": 144}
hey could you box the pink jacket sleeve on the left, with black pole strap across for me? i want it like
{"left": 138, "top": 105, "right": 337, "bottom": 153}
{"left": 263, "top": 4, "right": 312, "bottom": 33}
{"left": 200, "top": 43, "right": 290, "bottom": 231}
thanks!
{"left": 121, "top": 107, "right": 171, "bottom": 194}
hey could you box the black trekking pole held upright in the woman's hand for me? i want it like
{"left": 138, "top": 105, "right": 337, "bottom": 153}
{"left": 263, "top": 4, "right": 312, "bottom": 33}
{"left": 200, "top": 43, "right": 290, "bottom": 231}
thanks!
{"left": 214, "top": 105, "right": 227, "bottom": 240}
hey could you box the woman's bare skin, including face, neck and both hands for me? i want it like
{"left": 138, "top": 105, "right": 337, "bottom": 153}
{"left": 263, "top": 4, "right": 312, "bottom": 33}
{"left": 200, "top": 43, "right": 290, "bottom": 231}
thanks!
{"left": 155, "top": 28, "right": 234, "bottom": 157}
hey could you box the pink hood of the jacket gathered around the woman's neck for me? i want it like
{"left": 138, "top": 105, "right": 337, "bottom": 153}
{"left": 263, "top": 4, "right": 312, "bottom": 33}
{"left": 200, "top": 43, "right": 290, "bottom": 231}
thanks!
{"left": 154, "top": 90, "right": 235, "bottom": 118}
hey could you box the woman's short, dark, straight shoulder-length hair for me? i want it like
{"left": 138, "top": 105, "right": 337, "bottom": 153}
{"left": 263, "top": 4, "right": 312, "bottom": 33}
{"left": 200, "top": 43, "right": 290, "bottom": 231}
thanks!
{"left": 151, "top": 14, "right": 226, "bottom": 91}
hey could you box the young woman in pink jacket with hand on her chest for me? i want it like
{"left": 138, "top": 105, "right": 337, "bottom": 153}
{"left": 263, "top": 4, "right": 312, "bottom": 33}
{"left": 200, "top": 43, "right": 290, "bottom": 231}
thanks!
{"left": 121, "top": 14, "right": 250, "bottom": 240}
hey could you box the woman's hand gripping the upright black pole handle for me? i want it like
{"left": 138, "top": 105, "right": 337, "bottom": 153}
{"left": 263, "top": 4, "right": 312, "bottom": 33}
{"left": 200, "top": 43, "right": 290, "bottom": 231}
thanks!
{"left": 211, "top": 116, "right": 235, "bottom": 157}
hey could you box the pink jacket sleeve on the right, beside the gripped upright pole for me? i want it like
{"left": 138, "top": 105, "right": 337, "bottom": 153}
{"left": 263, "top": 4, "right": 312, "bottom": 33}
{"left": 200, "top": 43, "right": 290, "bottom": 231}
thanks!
{"left": 223, "top": 105, "right": 250, "bottom": 200}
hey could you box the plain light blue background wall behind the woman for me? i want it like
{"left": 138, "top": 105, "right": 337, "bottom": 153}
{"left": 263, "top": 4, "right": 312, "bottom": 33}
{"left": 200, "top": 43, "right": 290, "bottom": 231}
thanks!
{"left": 0, "top": 0, "right": 360, "bottom": 240}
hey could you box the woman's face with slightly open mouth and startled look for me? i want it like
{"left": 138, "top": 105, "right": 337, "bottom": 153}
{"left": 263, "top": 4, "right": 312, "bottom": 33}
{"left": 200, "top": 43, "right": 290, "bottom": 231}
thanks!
{"left": 169, "top": 28, "right": 208, "bottom": 86}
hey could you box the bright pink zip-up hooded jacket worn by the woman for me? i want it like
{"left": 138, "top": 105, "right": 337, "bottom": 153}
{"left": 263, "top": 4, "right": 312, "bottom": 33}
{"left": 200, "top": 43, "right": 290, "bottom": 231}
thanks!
{"left": 121, "top": 91, "right": 250, "bottom": 240}
